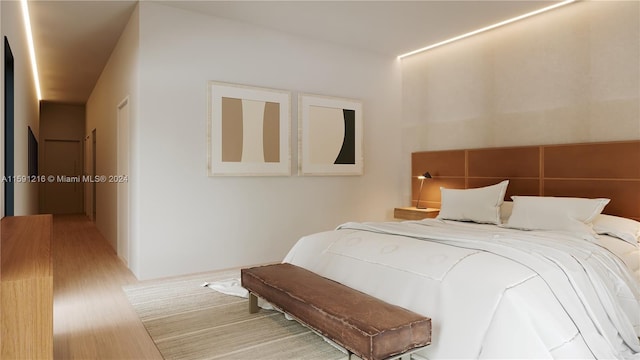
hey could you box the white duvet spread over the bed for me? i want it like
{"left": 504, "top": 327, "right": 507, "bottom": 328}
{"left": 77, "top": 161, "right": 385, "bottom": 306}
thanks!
{"left": 284, "top": 219, "right": 640, "bottom": 359}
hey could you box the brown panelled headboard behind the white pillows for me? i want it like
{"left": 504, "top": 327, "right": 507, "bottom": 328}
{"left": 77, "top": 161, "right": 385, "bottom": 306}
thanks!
{"left": 411, "top": 141, "right": 640, "bottom": 220}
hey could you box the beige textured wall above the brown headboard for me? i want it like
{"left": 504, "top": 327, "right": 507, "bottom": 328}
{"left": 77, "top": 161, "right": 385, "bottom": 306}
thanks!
{"left": 402, "top": 1, "right": 640, "bottom": 155}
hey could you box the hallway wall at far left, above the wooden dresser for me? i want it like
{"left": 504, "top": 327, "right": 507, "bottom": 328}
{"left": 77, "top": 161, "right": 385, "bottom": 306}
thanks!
{"left": 0, "top": 1, "right": 39, "bottom": 216}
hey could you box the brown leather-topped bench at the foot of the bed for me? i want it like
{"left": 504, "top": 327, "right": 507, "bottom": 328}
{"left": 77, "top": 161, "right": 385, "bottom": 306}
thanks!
{"left": 241, "top": 263, "right": 431, "bottom": 360}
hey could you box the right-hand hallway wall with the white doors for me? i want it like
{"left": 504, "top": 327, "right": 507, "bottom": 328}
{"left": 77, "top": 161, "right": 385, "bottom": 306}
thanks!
{"left": 85, "top": 9, "right": 138, "bottom": 250}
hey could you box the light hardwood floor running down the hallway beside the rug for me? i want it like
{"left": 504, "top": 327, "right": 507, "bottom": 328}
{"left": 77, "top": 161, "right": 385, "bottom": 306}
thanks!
{"left": 53, "top": 215, "right": 162, "bottom": 359}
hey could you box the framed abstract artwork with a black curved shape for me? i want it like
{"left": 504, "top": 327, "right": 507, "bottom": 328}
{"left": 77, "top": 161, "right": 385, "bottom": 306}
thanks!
{"left": 298, "top": 94, "right": 363, "bottom": 175}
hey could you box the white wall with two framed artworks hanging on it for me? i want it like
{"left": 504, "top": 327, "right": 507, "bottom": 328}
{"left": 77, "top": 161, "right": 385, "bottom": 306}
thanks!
{"left": 131, "top": 2, "right": 400, "bottom": 278}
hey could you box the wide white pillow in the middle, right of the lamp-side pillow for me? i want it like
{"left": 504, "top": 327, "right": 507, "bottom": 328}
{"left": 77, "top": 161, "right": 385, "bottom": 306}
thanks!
{"left": 506, "top": 196, "right": 610, "bottom": 240}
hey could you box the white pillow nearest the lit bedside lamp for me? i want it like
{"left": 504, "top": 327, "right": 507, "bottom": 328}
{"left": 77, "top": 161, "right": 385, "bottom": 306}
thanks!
{"left": 437, "top": 180, "right": 509, "bottom": 224}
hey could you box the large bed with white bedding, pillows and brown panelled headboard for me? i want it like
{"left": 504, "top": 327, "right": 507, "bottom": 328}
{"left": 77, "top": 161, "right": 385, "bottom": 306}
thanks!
{"left": 284, "top": 141, "right": 640, "bottom": 359}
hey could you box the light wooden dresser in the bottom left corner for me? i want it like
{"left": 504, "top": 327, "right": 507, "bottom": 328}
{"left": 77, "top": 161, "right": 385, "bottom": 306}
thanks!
{"left": 0, "top": 215, "right": 53, "bottom": 359}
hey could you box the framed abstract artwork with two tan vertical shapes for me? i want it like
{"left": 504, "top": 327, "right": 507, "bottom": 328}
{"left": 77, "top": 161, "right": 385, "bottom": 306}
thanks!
{"left": 207, "top": 81, "right": 291, "bottom": 176}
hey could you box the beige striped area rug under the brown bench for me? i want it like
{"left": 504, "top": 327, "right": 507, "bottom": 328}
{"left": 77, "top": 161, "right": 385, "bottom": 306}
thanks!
{"left": 123, "top": 270, "right": 348, "bottom": 360}
